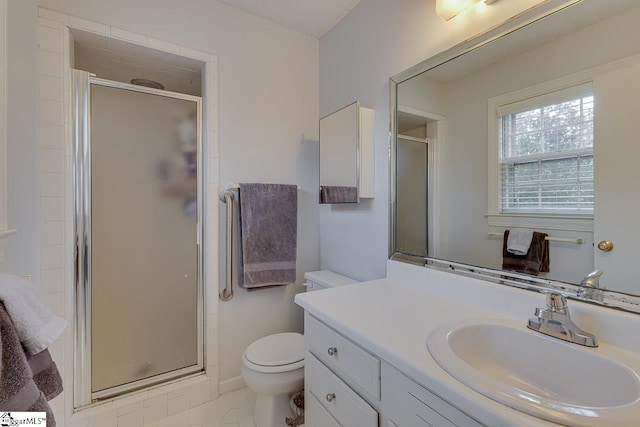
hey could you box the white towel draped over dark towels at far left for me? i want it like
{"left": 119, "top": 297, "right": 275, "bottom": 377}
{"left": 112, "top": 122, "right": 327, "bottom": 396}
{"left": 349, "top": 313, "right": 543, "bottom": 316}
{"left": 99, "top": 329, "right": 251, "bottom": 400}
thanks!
{"left": 0, "top": 274, "right": 68, "bottom": 355}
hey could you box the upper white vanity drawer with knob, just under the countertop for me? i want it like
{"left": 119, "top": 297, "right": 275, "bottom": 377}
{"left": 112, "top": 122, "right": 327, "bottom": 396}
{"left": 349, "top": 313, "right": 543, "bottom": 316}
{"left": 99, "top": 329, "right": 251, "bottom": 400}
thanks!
{"left": 304, "top": 314, "right": 380, "bottom": 400}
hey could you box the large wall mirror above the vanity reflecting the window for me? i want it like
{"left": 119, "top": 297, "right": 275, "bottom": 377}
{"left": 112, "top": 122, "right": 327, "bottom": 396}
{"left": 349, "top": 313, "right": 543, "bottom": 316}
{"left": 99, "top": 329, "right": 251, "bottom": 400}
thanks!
{"left": 390, "top": 0, "right": 640, "bottom": 310}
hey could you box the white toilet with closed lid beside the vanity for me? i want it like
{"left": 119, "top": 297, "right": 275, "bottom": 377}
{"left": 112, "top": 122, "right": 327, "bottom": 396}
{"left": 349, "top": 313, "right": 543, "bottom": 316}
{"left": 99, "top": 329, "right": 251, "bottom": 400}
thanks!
{"left": 241, "top": 270, "right": 357, "bottom": 427}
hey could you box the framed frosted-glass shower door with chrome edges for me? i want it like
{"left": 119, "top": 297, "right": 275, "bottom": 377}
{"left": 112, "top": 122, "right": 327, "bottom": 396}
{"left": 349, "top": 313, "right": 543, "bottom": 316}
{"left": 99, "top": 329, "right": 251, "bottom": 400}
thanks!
{"left": 73, "top": 70, "right": 204, "bottom": 407}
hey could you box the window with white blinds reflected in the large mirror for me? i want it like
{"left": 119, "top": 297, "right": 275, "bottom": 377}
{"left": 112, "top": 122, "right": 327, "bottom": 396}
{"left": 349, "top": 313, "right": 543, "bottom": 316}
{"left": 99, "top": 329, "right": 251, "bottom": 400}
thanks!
{"left": 497, "top": 84, "right": 594, "bottom": 215}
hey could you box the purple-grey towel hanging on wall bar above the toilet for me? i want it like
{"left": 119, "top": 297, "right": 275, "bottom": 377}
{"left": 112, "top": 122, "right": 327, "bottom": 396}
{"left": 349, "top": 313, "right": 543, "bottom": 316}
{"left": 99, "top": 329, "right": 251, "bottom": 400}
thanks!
{"left": 239, "top": 184, "right": 298, "bottom": 289}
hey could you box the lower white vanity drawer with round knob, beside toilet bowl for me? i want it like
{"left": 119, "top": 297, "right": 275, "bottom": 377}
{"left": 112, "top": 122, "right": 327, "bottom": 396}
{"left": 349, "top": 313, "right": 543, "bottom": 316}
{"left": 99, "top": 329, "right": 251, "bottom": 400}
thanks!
{"left": 304, "top": 352, "right": 378, "bottom": 427}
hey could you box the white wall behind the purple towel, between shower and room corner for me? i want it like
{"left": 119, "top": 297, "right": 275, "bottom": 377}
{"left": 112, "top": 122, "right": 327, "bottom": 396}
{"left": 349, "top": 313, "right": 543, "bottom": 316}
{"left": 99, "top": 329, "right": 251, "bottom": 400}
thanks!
{"left": 33, "top": 0, "right": 319, "bottom": 388}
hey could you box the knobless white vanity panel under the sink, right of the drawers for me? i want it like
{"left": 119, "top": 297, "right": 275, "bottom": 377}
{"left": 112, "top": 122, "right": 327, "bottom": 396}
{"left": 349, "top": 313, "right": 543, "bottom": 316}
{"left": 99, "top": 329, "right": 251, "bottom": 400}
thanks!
{"left": 382, "top": 364, "right": 483, "bottom": 427}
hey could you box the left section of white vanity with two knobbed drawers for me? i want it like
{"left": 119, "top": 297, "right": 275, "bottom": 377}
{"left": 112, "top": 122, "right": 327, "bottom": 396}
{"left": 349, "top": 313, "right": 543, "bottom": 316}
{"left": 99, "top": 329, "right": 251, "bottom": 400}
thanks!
{"left": 305, "top": 313, "right": 380, "bottom": 427}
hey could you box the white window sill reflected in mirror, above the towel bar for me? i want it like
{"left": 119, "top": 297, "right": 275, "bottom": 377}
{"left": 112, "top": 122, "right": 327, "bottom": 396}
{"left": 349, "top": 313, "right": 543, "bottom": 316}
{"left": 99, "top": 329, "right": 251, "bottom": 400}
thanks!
{"left": 486, "top": 214, "right": 593, "bottom": 233}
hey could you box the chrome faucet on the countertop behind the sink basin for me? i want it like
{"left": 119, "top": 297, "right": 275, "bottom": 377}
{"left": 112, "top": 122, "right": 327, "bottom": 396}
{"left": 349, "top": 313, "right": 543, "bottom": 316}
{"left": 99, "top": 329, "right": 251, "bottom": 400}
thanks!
{"left": 527, "top": 292, "right": 598, "bottom": 347}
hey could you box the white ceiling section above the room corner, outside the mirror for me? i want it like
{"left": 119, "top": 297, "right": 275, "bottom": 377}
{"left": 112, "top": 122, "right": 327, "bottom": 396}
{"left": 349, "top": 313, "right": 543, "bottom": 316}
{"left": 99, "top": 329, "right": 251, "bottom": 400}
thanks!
{"left": 220, "top": 0, "right": 360, "bottom": 38}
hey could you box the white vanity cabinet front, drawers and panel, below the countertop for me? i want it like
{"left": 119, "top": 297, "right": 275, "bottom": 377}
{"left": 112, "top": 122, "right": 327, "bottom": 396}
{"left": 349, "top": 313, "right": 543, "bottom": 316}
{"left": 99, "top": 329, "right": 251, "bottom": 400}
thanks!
{"left": 305, "top": 312, "right": 483, "bottom": 427}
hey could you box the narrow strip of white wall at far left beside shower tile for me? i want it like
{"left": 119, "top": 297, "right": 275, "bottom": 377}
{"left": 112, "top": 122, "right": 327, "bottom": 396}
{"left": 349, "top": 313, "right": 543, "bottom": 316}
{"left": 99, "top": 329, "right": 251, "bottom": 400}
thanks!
{"left": 0, "top": 0, "right": 40, "bottom": 282}
